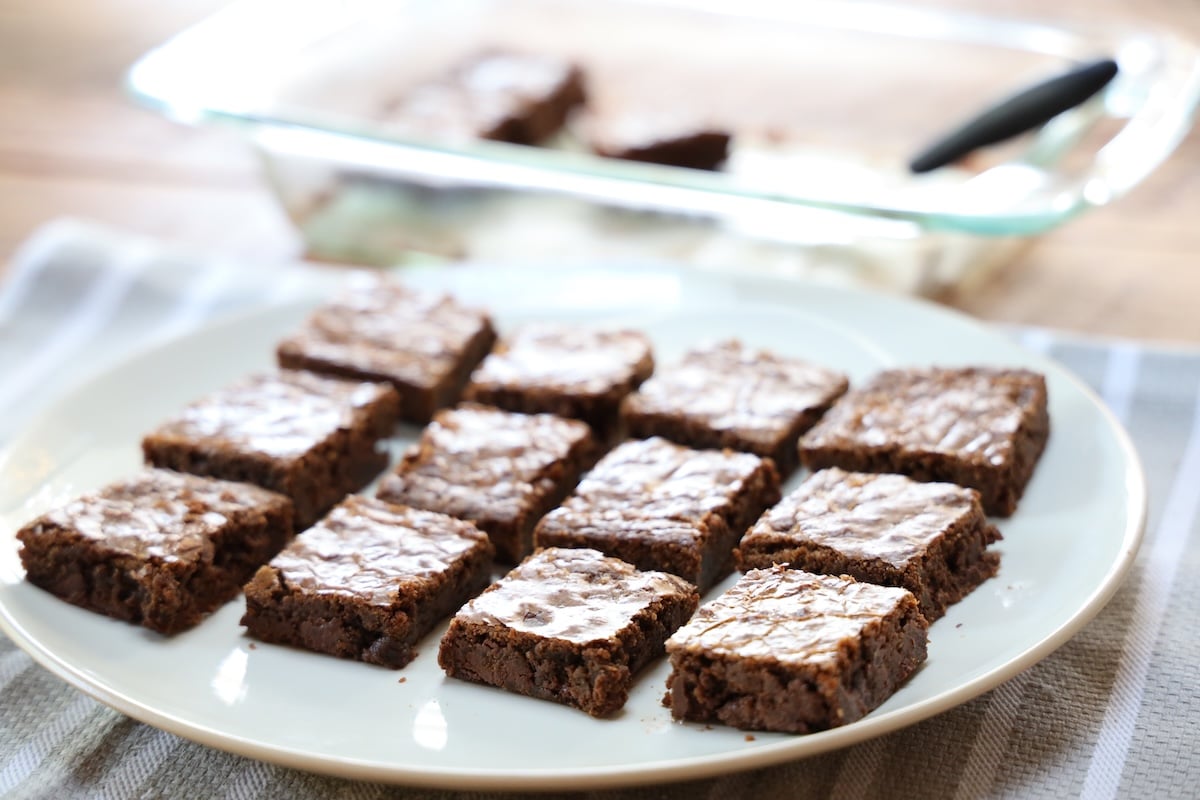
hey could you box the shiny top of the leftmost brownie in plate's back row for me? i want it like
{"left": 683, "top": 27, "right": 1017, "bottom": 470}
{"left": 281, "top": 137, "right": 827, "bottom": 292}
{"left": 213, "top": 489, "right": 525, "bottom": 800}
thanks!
{"left": 280, "top": 275, "right": 491, "bottom": 385}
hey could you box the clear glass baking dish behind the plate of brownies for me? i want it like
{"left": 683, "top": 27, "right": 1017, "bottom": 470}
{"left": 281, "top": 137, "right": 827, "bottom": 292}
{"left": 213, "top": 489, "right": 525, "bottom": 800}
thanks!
{"left": 127, "top": 0, "right": 1200, "bottom": 293}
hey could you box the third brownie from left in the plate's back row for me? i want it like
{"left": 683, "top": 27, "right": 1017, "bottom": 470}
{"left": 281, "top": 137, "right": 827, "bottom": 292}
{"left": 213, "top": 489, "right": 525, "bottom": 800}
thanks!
{"left": 622, "top": 339, "right": 848, "bottom": 476}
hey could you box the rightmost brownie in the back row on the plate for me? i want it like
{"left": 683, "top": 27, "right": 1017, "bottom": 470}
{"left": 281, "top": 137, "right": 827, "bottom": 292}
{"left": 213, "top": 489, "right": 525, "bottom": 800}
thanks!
{"left": 800, "top": 367, "right": 1050, "bottom": 517}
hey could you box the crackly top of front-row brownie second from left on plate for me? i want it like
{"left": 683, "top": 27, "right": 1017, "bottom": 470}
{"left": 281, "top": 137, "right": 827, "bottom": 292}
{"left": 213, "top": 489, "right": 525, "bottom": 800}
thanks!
{"left": 271, "top": 495, "right": 491, "bottom": 606}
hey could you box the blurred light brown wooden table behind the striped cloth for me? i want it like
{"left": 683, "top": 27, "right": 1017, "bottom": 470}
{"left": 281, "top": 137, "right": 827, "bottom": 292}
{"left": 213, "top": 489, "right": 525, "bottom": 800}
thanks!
{"left": 7, "top": 0, "right": 1200, "bottom": 342}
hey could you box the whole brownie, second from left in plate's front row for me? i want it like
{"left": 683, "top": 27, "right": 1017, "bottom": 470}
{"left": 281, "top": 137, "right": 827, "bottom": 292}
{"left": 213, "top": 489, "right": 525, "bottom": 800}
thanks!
{"left": 241, "top": 495, "right": 492, "bottom": 669}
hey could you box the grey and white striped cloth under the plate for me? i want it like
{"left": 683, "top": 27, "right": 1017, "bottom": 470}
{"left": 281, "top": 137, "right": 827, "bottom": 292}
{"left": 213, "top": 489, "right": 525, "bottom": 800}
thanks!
{"left": 0, "top": 222, "right": 1200, "bottom": 800}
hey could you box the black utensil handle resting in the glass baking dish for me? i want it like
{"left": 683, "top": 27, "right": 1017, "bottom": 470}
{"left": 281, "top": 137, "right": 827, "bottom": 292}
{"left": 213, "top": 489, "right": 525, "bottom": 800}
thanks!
{"left": 908, "top": 59, "right": 1117, "bottom": 173}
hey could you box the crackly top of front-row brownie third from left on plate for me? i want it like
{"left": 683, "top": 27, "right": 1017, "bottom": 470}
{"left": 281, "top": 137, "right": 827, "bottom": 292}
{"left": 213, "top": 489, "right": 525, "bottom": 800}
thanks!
{"left": 457, "top": 547, "right": 697, "bottom": 643}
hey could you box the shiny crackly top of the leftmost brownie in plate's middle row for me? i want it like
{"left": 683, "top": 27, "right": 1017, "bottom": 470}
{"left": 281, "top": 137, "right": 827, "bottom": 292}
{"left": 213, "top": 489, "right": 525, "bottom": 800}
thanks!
{"left": 149, "top": 369, "right": 395, "bottom": 458}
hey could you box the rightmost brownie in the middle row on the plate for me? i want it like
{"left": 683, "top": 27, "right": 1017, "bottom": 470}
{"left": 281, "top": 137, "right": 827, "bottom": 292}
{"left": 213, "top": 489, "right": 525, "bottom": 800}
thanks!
{"left": 736, "top": 467, "right": 1001, "bottom": 621}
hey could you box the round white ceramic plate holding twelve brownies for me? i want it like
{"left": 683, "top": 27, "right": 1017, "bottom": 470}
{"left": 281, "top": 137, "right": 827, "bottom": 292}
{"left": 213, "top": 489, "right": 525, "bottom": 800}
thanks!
{"left": 0, "top": 267, "right": 1145, "bottom": 789}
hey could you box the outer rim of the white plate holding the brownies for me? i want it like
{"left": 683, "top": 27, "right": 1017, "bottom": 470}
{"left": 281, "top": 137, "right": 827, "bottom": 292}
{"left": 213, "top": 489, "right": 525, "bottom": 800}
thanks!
{"left": 0, "top": 263, "right": 1148, "bottom": 792}
